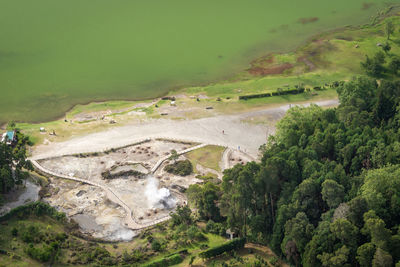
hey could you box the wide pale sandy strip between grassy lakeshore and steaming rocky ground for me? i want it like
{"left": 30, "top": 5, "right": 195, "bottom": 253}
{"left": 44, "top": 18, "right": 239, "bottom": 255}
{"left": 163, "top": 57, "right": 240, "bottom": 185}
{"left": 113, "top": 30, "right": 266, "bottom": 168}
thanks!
{"left": 32, "top": 99, "right": 338, "bottom": 159}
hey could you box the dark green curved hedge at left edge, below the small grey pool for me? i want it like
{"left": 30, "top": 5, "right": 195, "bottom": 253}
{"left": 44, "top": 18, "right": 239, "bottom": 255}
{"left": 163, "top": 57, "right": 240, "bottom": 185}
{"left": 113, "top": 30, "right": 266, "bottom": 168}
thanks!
{"left": 0, "top": 201, "right": 66, "bottom": 222}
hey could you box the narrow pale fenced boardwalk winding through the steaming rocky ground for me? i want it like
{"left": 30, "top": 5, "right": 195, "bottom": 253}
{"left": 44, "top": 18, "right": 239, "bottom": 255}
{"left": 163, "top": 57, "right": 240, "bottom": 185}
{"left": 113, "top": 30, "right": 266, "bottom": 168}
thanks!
{"left": 30, "top": 144, "right": 207, "bottom": 230}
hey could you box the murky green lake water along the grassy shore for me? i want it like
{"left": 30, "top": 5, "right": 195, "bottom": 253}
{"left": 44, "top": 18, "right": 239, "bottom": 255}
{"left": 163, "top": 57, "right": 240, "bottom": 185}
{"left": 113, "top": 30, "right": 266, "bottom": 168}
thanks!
{"left": 0, "top": 0, "right": 394, "bottom": 122}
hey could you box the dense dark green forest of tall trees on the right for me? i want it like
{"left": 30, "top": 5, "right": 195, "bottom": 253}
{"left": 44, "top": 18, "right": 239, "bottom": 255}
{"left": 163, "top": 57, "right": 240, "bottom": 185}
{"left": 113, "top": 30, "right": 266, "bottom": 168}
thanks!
{"left": 188, "top": 61, "right": 400, "bottom": 267}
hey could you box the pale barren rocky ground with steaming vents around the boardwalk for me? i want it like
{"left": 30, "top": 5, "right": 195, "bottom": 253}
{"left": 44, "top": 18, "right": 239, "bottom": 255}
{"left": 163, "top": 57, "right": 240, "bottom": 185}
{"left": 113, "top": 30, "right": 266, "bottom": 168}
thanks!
{"left": 39, "top": 140, "right": 209, "bottom": 240}
